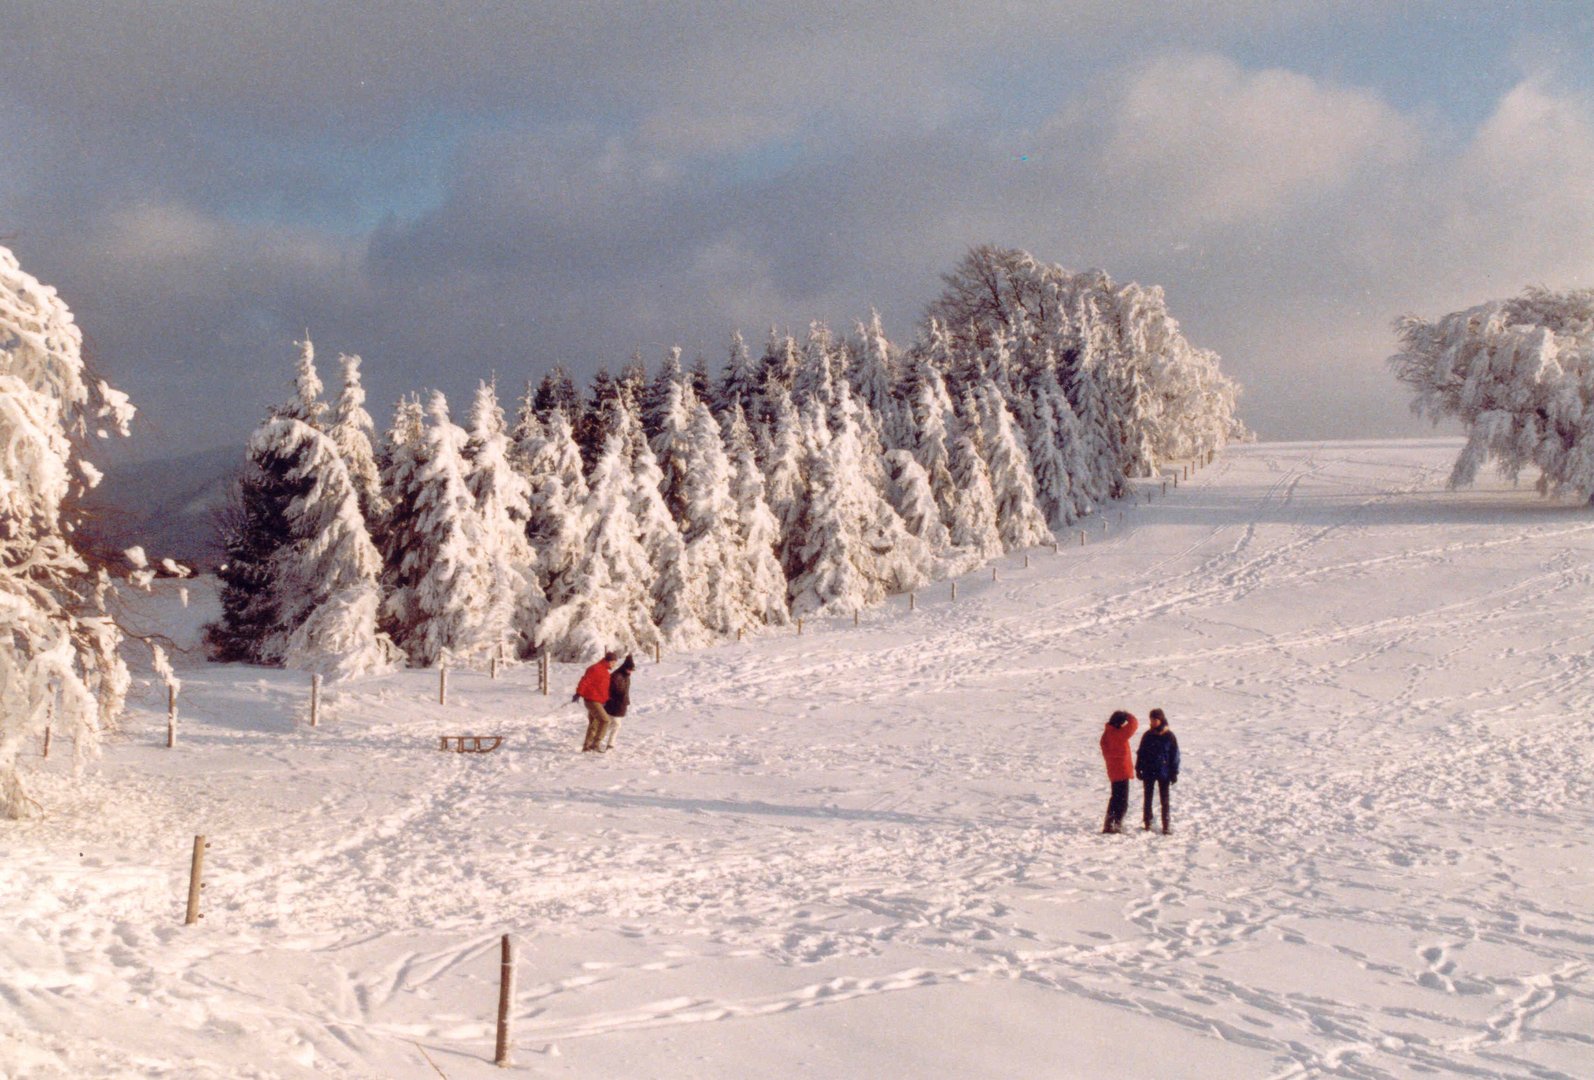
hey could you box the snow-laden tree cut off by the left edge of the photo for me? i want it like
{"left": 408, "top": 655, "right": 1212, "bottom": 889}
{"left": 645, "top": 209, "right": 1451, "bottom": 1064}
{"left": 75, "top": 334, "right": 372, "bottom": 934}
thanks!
{"left": 0, "top": 247, "right": 132, "bottom": 817}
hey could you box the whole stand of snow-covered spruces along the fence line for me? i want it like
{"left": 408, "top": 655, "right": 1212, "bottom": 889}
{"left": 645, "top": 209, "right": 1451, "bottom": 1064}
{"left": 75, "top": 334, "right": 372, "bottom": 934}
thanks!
{"left": 209, "top": 247, "right": 1243, "bottom": 677}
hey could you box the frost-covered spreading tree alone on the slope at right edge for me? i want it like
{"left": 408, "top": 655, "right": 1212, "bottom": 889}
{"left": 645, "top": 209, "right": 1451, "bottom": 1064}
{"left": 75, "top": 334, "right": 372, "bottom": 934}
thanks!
{"left": 1390, "top": 288, "right": 1594, "bottom": 500}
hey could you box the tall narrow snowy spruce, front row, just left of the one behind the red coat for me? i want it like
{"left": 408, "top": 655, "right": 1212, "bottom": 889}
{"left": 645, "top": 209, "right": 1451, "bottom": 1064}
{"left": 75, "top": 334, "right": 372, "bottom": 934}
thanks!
{"left": 465, "top": 382, "right": 548, "bottom": 669}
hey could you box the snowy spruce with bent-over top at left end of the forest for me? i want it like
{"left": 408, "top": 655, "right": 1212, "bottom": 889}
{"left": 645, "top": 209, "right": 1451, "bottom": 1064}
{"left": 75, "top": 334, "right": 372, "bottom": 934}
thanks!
{"left": 250, "top": 416, "right": 402, "bottom": 679}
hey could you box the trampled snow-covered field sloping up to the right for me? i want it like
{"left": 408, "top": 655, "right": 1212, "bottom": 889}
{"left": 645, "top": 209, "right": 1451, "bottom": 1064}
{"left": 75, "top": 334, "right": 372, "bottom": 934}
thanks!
{"left": 0, "top": 441, "right": 1594, "bottom": 1080}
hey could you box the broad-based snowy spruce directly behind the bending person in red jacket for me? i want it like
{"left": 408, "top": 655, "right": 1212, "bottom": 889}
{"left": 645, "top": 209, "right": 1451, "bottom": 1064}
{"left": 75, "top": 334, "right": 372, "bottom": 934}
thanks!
{"left": 537, "top": 432, "right": 658, "bottom": 661}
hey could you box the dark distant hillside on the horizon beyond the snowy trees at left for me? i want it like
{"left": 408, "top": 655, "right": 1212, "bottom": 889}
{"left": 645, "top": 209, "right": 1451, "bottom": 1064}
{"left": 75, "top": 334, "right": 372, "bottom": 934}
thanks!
{"left": 84, "top": 446, "right": 244, "bottom": 565}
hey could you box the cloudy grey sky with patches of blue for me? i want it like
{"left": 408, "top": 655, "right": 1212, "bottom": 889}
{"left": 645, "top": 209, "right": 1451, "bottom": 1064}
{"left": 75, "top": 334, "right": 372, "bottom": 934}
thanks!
{"left": 0, "top": 0, "right": 1594, "bottom": 457}
